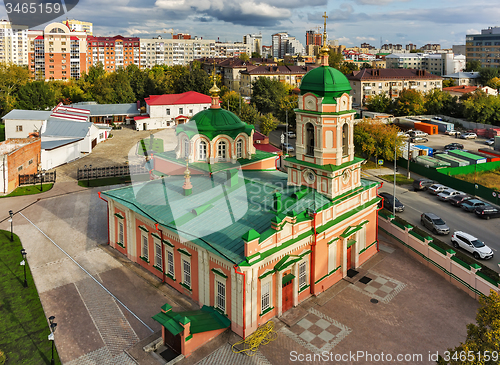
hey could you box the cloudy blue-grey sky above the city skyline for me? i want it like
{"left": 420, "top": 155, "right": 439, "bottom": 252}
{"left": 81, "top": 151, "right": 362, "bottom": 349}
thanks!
{"left": 0, "top": 0, "right": 500, "bottom": 48}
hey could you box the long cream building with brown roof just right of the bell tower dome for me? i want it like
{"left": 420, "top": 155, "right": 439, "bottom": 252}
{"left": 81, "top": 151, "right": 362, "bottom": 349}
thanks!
{"left": 347, "top": 68, "right": 443, "bottom": 106}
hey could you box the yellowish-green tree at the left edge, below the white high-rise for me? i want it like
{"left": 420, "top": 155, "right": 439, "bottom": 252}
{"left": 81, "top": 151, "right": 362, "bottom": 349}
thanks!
{"left": 0, "top": 63, "right": 30, "bottom": 116}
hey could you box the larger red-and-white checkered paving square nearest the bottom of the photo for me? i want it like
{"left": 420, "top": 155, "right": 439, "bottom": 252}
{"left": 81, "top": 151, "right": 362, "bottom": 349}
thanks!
{"left": 281, "top": 308, "right": 351, "bottom": 353}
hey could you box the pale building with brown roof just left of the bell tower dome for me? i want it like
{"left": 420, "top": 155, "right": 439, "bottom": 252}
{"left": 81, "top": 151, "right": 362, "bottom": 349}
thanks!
{"left": 240, "top": 66, "right": 317, "bottom": 96}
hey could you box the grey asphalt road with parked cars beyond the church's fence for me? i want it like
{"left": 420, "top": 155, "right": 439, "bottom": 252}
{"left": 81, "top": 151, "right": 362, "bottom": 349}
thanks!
{"left": 380, "top": 182, "right": 500, "bottom": 272}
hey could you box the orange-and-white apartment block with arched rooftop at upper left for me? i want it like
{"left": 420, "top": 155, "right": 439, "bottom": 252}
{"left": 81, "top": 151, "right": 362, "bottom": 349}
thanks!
{"left": 28, "top": 23, "right": 88, "bottom": 80}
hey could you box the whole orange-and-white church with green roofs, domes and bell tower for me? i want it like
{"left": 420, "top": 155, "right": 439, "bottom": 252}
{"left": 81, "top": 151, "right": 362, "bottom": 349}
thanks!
{"left": 102, "top": 24, "right": 380, "bottom": 356}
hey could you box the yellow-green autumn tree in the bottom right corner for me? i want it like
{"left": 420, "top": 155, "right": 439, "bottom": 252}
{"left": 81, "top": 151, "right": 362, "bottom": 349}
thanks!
{"left": 438, "top": 290, "right": 500, "bottom": 365}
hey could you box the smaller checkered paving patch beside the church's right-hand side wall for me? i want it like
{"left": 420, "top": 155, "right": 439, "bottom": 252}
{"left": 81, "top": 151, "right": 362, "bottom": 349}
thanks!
{"left": 349, "top": 270, "right": 406, "bottom": 303}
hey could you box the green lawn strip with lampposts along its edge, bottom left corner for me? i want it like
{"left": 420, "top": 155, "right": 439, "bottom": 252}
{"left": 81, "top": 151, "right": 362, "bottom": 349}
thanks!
{"left": 0, "top": 230, "right": 61, "bottom": 365}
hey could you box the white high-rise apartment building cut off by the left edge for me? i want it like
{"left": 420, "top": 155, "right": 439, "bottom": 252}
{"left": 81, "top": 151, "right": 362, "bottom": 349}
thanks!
{"left": 0, "top": 20, "right": 28, "bottom": 65}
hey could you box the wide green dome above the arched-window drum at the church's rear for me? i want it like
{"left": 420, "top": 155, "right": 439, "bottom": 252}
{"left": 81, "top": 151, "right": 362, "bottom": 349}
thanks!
{"left": 176, "top": 108, "right": 254, "bottom": 139}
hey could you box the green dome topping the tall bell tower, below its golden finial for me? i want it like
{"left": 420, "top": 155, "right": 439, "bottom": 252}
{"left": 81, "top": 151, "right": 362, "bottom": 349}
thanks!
{"left": 300, "top": 66, "right": 352, "bottom": 96}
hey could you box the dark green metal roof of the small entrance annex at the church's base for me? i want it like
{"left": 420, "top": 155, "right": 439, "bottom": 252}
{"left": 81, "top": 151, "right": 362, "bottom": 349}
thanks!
{"left": 152, "top": 305, "right": 231, "bottom": 336}
